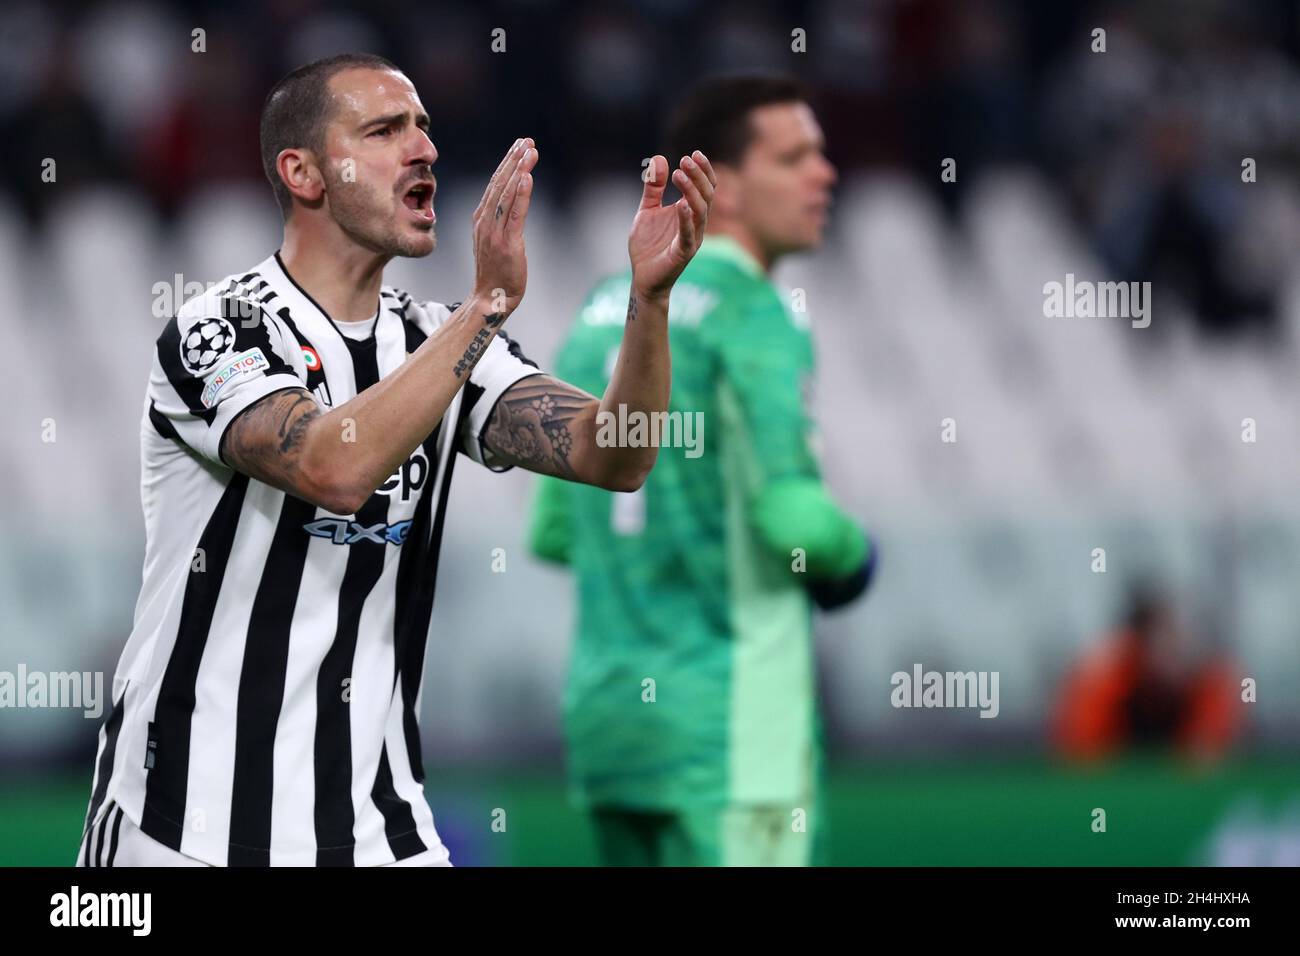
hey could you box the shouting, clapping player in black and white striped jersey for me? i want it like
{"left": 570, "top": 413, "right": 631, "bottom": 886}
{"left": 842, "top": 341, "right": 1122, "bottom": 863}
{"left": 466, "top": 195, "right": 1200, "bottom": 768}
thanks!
{"left": 78, "top": 55, "right": 712, "bottom": 866}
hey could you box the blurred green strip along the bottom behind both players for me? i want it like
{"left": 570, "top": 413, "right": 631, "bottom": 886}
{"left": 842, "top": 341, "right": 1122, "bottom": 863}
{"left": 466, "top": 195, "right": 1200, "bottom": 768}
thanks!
{"left": 0, "top": 758, "right": 1300, "bottom": 866}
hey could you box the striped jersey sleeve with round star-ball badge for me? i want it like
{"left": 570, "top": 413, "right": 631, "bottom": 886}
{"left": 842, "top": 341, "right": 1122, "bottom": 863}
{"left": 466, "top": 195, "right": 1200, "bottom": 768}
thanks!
{"left": 150, "top": 297, "right": 304, "bottom": 466}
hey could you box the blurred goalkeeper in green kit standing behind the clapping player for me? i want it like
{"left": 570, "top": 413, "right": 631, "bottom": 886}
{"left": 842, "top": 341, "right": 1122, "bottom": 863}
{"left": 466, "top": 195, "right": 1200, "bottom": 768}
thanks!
{"left": 530, "top": 75, "right": 875, "bottom": 865}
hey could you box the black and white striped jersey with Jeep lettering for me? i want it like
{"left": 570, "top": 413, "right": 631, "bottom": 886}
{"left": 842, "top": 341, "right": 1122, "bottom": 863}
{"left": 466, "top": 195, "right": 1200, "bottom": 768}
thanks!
{"left": 86, "top": 254, "right": 538, "bottom": 865}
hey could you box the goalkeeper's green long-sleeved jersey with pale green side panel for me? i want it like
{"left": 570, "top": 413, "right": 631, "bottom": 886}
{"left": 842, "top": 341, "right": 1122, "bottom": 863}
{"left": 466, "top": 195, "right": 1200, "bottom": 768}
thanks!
{"left": 532, "top": 237, "right": 867, "bottom": 809}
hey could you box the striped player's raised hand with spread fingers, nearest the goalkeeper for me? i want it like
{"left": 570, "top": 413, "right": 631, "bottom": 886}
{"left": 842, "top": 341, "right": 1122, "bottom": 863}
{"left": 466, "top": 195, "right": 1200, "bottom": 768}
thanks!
{"left": 628, "top": 150, "right": 718, "bottom": 298}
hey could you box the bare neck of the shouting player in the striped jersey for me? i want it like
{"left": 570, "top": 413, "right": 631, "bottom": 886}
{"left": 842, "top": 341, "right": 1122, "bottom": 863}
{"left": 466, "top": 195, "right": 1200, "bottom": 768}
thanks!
{"left": 280, "top": 222, "right": 389, "bottom": 323}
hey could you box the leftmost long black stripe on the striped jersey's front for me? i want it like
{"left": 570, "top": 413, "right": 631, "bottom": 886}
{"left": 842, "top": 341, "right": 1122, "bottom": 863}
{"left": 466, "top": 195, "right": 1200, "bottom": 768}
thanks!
{"left": 140, "top": 472, "right": 248, "bottom": 852}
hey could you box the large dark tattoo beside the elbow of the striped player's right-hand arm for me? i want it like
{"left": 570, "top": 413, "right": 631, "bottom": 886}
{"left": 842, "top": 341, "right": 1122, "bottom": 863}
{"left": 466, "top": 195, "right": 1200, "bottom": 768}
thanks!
{"left": 484, "top": 375, "right": 597, "bottom": 481}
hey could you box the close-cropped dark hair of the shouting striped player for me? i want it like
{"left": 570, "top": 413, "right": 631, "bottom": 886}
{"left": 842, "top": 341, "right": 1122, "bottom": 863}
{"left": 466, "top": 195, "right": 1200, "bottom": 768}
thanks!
{"left": 260, "top": 53, "right": 402, "bottom": 220}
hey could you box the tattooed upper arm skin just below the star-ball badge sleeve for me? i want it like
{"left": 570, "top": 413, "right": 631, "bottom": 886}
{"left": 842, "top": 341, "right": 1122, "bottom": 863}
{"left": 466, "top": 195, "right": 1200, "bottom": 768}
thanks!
{"left": 221, "top": 389, "right": 321, "bottom": 488}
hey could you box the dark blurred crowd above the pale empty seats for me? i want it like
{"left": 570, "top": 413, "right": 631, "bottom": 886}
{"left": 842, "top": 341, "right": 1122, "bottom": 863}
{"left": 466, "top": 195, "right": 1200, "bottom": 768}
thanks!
{"left": 0, "top": 0, "right": 1300, "bottom": 332}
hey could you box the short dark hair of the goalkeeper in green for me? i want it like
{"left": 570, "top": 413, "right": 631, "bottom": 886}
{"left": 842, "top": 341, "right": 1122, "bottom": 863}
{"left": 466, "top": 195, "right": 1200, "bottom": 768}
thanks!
{"left": 666, "top": 73, "right": 809, "bottom": 169}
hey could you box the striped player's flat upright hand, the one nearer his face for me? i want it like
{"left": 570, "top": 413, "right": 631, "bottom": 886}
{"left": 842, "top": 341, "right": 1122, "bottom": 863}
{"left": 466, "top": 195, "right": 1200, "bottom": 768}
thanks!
{"left": 473, "top": 137, "right": 537, "bottom": 313}
